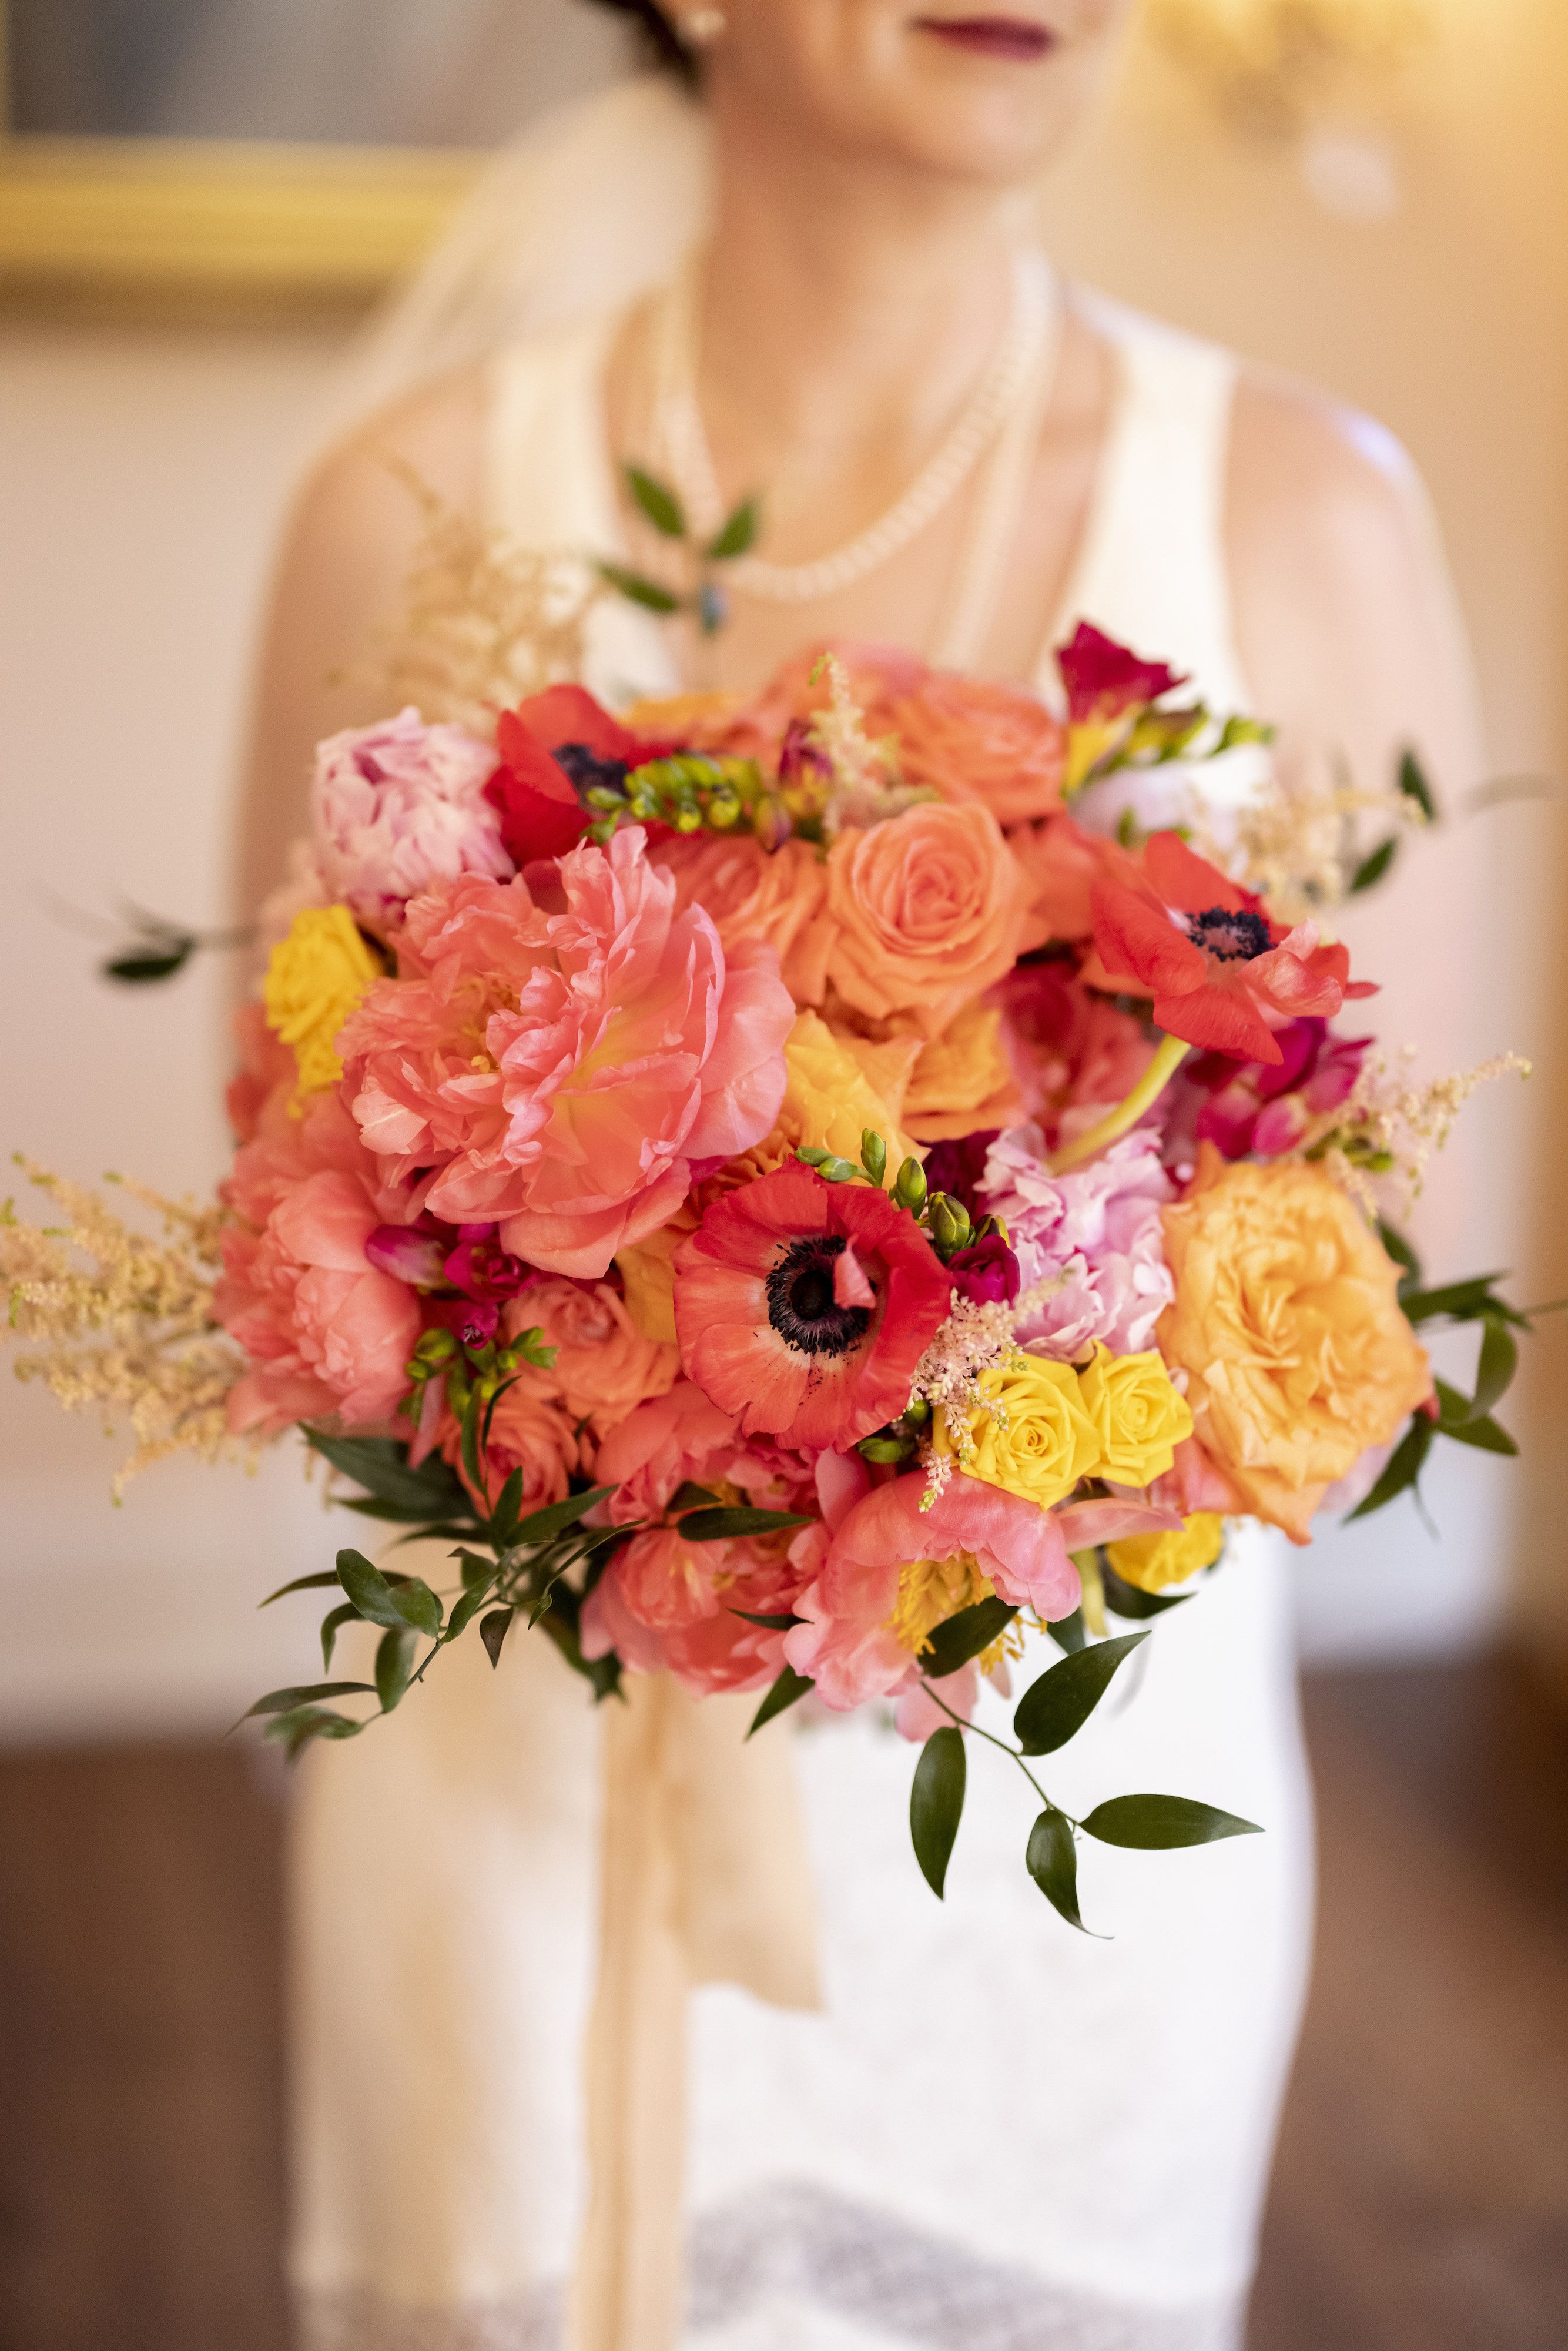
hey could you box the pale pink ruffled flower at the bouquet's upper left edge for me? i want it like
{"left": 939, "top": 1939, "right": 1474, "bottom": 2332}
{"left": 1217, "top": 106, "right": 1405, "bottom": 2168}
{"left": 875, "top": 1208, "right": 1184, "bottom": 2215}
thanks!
{"left": 310, "top": 708, "right": 512, "bottom": 929}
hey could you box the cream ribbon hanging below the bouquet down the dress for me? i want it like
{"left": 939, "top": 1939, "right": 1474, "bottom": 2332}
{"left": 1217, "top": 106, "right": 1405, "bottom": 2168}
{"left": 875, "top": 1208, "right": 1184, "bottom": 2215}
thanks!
{"left": 569, "top": 1674, "right": 820, "bottom": 2351}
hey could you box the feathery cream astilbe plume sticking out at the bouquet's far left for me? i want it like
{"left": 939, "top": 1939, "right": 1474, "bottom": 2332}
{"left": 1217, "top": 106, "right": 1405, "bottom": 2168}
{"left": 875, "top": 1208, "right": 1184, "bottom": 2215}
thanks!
{"left": 0, "top": 1154, "right": 256, "bottom": 1498}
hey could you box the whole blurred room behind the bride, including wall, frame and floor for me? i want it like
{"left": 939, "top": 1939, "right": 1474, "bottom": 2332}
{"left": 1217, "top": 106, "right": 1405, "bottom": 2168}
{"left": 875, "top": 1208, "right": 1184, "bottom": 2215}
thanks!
{"left": 0, "top": 0, "right": 1568, "bottom": 2351}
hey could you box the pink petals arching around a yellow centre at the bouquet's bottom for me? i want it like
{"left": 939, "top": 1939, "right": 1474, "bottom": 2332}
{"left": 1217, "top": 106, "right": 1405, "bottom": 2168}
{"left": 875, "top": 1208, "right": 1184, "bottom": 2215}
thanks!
{"left": 785, "top": 1472, "right": 1079, "bottom": 1709}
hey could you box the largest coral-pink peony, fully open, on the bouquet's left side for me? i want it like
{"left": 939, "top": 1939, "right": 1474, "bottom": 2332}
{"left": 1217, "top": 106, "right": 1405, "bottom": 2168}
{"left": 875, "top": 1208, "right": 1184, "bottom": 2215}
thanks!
{"left": 339, "top": 825, "right": 795, "bottom": 1277}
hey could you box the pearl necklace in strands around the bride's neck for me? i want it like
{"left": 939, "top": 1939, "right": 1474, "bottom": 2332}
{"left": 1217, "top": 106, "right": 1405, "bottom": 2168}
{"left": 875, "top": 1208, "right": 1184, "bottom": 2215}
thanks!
{"left": 651, "top": 252, "right": 1060, "bottom": 644}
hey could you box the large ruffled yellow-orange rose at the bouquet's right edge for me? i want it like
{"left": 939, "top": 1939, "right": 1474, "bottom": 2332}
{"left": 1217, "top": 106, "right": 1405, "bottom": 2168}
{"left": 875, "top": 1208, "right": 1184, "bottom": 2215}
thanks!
{"left": 1159, "top": 1145, "right": 1432, "bottom": 1542}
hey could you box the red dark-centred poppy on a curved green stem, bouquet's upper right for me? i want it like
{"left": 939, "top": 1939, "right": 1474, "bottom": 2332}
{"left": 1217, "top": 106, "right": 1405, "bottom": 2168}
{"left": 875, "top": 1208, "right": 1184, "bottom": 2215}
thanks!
{"left": 1091, "top": 832, "right": 1375, "bottom": 1063}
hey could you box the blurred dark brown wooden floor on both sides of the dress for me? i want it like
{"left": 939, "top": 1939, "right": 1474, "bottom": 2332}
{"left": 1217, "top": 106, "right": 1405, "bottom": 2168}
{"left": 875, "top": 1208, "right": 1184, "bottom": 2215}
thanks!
{"left": 0, "top": 1662, "right": 1568, "bottom": 2351}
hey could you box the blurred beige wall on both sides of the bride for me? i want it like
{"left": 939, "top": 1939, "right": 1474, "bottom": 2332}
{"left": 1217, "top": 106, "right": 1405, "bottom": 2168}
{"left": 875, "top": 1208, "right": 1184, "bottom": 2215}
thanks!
{"left": 0, "top": 0, "right": 1568, "bottom": 1735}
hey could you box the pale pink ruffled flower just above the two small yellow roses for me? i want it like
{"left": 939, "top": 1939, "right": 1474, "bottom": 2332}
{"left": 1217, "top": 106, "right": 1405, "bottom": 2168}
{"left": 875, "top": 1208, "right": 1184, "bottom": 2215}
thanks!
{"left": 980, "top": 1126, "right": 1175, "bottom": 1364}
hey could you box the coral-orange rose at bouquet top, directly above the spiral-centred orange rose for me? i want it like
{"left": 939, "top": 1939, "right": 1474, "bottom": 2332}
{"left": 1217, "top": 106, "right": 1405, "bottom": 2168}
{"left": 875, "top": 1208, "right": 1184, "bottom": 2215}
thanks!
{"left": 893, "top": 672, "right": 1067, "bottom": 825}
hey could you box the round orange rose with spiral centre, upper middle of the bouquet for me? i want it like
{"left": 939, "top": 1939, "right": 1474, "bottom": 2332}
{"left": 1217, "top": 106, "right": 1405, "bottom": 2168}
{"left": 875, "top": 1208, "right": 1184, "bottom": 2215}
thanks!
{"left": 827, "top": 802, "right": 1020, "bottom": 1037}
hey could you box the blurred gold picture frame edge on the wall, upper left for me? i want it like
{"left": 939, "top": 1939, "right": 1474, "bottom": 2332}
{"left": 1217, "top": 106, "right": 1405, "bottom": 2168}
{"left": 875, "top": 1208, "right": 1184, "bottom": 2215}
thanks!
{"left": 0, "top": 0, "right": 484, "bottom": 317}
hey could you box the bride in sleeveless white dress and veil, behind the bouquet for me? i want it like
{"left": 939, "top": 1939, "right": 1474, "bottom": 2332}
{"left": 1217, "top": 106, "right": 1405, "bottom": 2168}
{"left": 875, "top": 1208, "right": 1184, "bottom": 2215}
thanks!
{"left": 249, "top": 0, "right": 1479, "bottom": 2351}
